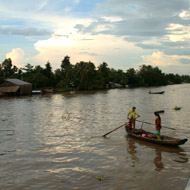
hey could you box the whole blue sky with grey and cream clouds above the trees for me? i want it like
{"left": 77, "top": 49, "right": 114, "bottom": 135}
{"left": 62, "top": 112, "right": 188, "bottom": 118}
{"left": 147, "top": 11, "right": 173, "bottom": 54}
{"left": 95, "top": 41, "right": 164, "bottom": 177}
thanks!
{"left": 0, "top": 0, "right": 190, "bottom": 75}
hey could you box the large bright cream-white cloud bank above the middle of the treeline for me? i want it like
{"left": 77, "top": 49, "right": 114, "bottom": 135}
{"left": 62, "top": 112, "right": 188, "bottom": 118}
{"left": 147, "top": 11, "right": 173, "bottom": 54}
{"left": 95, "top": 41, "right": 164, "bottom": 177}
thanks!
{"left": 34, "top": 34, "right": 142, "bottom": 68}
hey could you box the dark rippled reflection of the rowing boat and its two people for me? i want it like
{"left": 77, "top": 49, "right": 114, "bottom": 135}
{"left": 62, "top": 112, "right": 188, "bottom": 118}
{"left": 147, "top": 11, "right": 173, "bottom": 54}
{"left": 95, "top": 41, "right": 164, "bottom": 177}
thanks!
{"left": 126, "top": 136, "right": 189, "bottom": 171}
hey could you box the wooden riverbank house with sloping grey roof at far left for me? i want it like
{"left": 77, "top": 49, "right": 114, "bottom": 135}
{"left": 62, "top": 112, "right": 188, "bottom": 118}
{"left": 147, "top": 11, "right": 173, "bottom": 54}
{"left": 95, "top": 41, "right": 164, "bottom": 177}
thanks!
{"left": 0, "top": 79, "right": 32, "bottom": 95}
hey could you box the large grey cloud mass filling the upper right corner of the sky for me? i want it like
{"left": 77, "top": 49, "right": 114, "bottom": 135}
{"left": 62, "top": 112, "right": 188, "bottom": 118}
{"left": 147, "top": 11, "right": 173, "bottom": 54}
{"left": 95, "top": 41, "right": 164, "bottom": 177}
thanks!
{"left": 75, "top": 0, "right": 190, "bottom": 58}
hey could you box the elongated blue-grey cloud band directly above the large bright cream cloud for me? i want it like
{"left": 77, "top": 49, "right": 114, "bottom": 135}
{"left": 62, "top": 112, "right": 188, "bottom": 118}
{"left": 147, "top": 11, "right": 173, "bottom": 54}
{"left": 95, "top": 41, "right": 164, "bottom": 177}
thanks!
{"left": 75, "top": 18, "right": 168, "bottom": 37}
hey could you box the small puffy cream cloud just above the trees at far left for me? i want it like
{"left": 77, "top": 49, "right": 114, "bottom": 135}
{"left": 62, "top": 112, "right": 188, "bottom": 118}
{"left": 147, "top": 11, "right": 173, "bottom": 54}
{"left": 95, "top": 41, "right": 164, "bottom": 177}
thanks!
{"left": 6, "top": 48, "right": 26, "bottom": 68}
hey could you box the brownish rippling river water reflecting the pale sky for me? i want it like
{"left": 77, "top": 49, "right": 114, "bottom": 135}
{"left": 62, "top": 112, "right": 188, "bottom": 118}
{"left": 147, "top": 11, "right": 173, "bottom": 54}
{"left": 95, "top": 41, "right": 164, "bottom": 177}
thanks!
{"left": 0, "top": 84, "right": 190, "bottom": 190}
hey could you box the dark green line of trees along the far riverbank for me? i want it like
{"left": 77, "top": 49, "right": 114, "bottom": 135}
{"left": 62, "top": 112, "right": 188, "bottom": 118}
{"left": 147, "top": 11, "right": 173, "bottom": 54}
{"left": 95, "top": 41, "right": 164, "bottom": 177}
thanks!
{"left": 0, "top": 56, "right": 190, "bottom": 90}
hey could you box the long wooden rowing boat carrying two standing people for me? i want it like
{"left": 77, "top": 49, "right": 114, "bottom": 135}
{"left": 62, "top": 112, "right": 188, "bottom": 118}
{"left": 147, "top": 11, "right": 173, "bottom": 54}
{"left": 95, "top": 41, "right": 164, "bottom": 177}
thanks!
{"left": 125, "top": 125, "right": 188, "bottom": 146}
